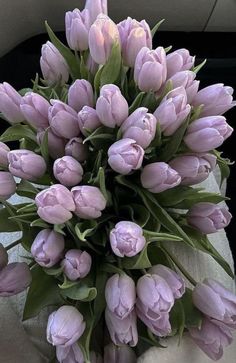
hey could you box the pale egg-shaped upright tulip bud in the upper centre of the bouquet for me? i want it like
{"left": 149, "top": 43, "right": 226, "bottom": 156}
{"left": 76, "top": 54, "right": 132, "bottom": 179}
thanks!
{"left": 96, "top": 84, "right": 129, "bottom": 128}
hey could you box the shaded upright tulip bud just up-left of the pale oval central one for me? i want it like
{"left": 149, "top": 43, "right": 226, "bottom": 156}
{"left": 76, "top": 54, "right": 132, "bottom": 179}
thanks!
{"left": 68, "top": 79, "right": 94, "bottom": 112}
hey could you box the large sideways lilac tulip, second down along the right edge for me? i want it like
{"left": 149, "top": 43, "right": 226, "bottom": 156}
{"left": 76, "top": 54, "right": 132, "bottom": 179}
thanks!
{"left": 184, "top": 116, "right": 233, "bottom": 152}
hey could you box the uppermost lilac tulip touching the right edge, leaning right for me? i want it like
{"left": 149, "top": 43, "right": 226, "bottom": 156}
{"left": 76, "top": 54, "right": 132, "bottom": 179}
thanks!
{"left": 192, "top": 83, "right": 236, "bottom": 117}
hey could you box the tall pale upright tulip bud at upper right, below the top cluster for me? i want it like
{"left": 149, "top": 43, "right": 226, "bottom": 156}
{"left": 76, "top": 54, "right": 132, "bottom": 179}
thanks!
{"left": 134, "top": 47, "right": 167, "bottom": 92}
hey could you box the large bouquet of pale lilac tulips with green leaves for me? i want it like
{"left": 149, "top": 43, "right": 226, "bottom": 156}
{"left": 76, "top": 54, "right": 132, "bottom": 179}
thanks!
{"left": 0, "top": 0, "right": 236, "bottom": 363}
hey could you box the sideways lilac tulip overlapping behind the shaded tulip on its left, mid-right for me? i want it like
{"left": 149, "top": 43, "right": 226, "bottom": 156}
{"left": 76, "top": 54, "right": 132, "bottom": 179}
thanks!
{"left": 169, "top": 154, "right": 216, "bottom": 185}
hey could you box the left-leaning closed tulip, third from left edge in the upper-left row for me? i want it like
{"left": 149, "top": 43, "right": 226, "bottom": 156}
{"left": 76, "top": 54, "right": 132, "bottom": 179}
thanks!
{"left": 48, "top": 100, "right": 80, "bottom": 139}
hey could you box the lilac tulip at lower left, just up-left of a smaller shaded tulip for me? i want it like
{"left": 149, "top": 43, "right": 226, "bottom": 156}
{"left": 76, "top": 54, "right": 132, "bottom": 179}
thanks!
{"left": 31, "top": 229, "right": 65, "bottom": 267}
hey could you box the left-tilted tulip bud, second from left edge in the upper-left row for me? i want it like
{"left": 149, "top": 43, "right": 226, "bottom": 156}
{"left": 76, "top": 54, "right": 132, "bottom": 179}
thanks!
{"left": 20, "top": 92, "right": 50, "bottom": 129}
